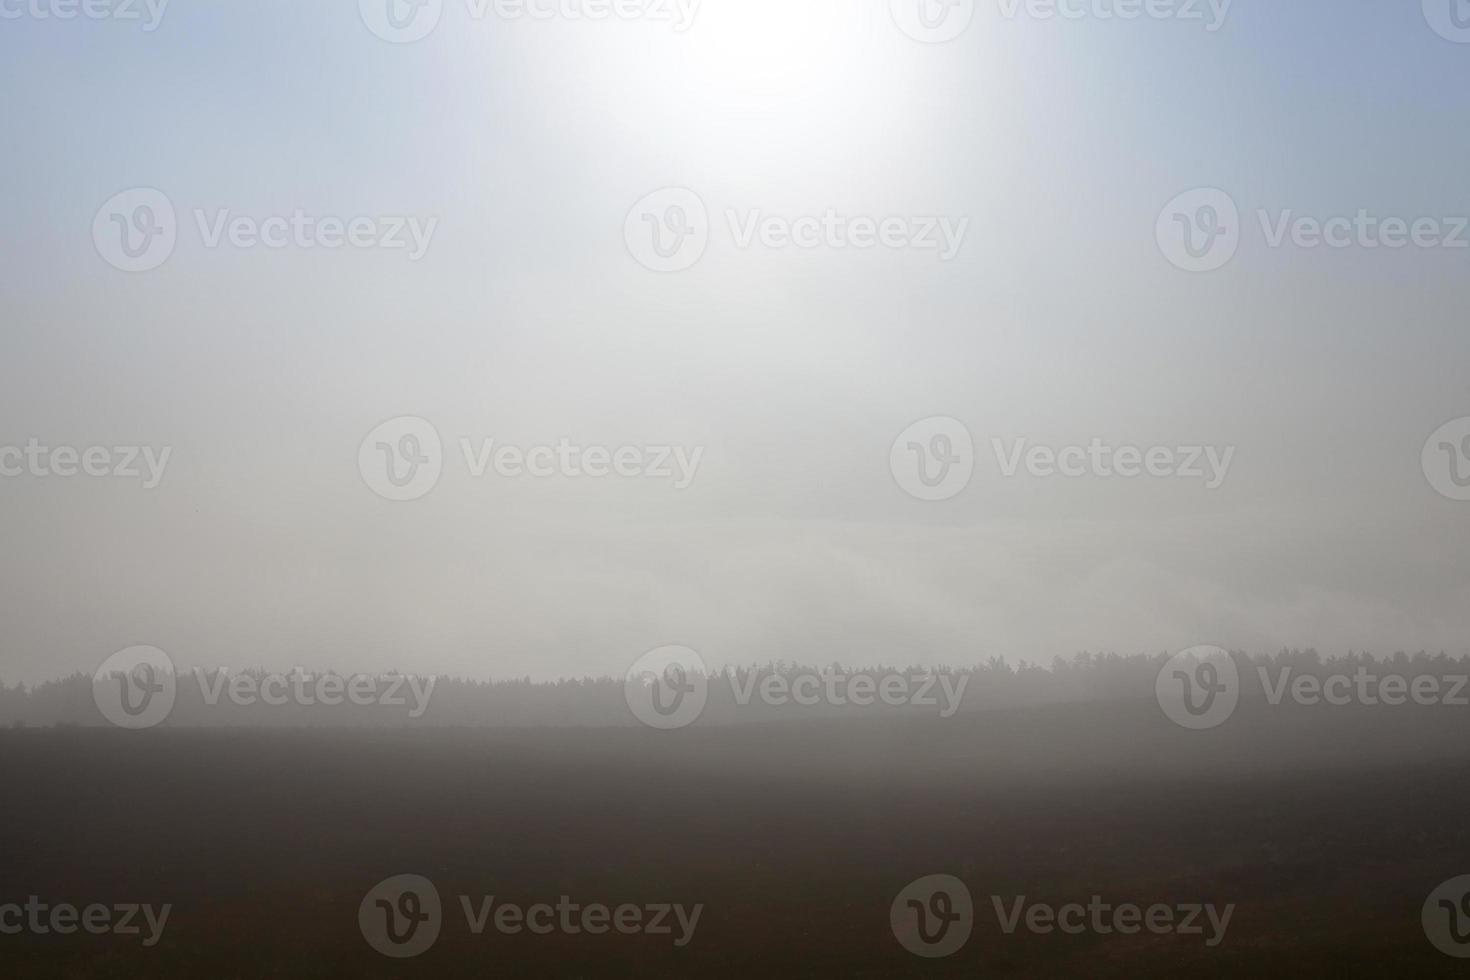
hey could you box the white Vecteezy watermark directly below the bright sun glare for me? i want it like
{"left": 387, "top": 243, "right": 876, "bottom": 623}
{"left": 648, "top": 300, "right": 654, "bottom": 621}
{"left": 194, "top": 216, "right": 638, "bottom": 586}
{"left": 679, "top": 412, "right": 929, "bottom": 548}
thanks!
{"left": 623, "top": 187, "right": 970, "bottom": 272}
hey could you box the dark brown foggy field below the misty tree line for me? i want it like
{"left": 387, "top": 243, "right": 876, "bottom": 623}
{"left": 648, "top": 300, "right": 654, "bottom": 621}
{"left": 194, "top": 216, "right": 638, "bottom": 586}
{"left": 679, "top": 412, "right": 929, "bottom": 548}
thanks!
{"left": 0, "top": 693, "right": 1470, "bottom": 980}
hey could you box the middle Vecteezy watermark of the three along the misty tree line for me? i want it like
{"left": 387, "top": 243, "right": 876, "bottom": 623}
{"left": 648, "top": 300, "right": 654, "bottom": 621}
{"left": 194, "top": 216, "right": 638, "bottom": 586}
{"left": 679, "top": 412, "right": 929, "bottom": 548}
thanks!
{"left": 623, "top": 646, "right": 970, "bottom": 730}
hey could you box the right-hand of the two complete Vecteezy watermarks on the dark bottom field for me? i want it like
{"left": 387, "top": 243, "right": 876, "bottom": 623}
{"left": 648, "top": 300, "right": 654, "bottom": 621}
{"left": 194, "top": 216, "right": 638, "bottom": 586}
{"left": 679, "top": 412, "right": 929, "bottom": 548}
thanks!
{"left": 888, "top": 874, "right": 1235, "bottom": 959}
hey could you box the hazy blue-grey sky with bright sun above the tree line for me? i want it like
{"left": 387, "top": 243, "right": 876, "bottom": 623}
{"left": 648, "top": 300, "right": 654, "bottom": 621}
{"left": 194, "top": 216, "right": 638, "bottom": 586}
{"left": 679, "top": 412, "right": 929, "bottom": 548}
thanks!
{"left": 0, "top": 0, "right": 1470, "bottom": 683}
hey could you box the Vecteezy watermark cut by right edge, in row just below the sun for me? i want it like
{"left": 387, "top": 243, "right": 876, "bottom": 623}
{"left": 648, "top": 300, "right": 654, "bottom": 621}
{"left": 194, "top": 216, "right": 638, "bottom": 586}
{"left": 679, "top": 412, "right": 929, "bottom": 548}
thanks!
{"left": 1155, "top": 188, "right": 1470, "bottom": 272}
